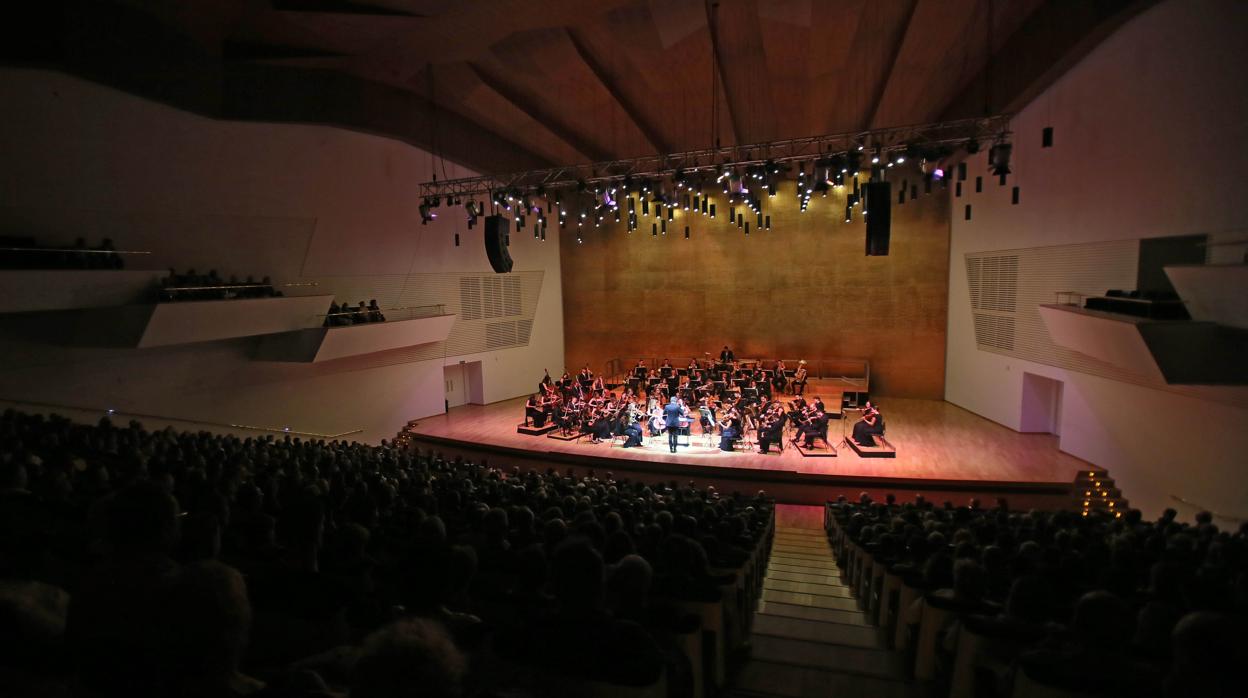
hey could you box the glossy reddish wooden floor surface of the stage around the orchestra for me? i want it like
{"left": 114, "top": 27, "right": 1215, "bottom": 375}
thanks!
{"left": 411, "top": 398, "right": 1088, "bottom": 484}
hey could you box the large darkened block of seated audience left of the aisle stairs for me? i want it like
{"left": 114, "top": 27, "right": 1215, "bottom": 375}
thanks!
{"left": 0, "top": 410, "right": 774, "bottom": 698}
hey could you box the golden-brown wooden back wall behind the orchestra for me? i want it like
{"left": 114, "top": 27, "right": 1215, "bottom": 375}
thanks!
{"left": 561, "top": 172, "right": 950, "bottom": 398}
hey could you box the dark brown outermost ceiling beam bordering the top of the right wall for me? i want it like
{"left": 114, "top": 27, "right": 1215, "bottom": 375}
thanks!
{"left": 941, "top": 0, "right": 1158, "bottom": 119}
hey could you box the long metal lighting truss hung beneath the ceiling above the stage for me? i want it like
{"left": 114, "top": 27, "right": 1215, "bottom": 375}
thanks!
{"left": 419, "top": 114, "right": 1011, "bottom": 199}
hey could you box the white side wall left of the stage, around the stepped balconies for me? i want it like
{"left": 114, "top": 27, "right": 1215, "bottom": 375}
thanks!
{"left": 0, "top": 70, "right": 563, "bottom": 442}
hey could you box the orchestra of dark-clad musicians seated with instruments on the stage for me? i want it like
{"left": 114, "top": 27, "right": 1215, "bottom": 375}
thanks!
{"left": 524, "top": 346, "right": 884, "bottom": 453}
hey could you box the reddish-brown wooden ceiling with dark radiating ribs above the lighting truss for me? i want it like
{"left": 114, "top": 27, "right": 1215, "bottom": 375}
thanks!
{"left": 75, "top": 0, "right": 1148, "bottom": 172}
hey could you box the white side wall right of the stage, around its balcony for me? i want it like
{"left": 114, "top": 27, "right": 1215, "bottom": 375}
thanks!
{"left": 946, "top": 0, "right": 1248, "bottom": 516}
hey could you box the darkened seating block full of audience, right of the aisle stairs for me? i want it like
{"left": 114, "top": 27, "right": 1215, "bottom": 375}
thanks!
{"left": 825, "top": 494, "right": 1248, "bottom": 698}
